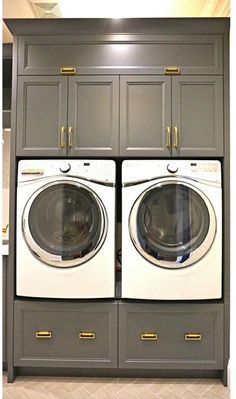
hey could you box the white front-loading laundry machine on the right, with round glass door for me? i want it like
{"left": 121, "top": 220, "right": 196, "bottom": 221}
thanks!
{"left": 122, "top": 160, "right": 222, "bottom": 300}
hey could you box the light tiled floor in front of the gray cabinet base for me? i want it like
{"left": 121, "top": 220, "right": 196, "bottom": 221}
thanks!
{"left": 3, "top": 375, "right": 230, "bottom": 399}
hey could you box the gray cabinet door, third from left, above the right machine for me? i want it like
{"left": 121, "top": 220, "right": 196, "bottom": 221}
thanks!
{"left": 120, "top": 76, "right": 171, "bottom": 157}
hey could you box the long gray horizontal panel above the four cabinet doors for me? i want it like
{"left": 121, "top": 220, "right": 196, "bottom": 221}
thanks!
{"left": 18, "top": 35, "right": 223, "bottom": 75}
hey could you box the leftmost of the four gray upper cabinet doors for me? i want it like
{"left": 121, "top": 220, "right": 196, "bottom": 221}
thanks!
{"left": 17, "top": 76, "right": 67, "bottom": 156}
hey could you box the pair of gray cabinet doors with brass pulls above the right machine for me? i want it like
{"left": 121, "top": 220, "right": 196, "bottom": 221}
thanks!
{"left": 120, "top": 75, "right": 223, "bottom": 157}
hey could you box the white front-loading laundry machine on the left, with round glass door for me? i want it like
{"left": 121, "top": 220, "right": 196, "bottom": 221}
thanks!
{"left": 16, "top": 159, "right": 116, "bottom": 298}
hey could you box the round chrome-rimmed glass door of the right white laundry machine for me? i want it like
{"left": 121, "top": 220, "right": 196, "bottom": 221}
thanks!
{"left": 129, "top": 181, "right": 216, "bottom": 269}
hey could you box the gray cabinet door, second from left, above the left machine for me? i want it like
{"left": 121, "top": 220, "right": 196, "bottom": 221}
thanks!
{"left": 68, "top": 76, "right": 119, "bottom": 156}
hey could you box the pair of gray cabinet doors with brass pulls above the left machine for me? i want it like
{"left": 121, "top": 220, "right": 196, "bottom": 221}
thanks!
{"left": 17, "top": 76, "right": 119, "bottom": 156}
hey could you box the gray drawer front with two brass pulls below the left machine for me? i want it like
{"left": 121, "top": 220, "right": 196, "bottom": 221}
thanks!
{"left": 14, "top": 301, "right": 117, "bottom": 368}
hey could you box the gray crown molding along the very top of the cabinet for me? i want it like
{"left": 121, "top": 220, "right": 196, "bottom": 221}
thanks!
{"left": 4, "top": 18, "right": 230, "bottom": 36}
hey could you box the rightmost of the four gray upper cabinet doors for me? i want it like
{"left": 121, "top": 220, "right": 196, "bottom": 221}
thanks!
{"left": 172, "top": 76, "right": 223, "bottom": 156}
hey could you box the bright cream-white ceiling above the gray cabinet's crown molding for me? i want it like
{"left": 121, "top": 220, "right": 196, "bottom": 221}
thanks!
{"left": 3, "top": 0, "right": 230, "bottom": 43}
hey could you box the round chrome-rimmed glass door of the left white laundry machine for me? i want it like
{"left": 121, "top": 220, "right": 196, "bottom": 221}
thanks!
{"left": 23, "top": 180, "right": 107, "bottom": 267}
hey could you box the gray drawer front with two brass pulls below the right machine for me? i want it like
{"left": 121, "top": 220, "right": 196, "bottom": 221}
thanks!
{"left": 119, "top": 304, "right": 223, "bottom": 369}
